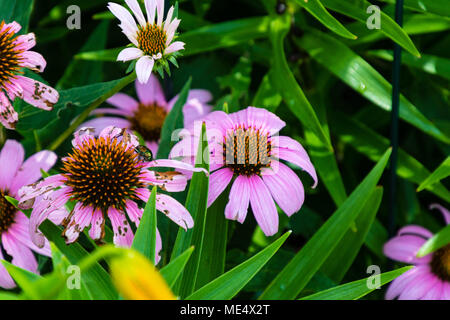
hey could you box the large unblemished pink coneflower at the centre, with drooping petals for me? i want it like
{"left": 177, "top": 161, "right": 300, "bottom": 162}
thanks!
{"left": 170, "top": 107, "right": 317, "bottom": 236}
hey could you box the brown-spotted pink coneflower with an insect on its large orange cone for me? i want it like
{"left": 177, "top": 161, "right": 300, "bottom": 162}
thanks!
{"left": 19, "top": 126, "right": 204, "bottom": 262}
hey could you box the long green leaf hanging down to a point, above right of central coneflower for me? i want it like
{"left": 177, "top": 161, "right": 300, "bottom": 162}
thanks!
{"left": 269, "top": 18, "right": 333, "bottom": 150}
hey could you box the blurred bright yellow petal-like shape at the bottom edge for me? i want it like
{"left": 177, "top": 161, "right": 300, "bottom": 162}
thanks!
{"left": 110, "top": 250, "right": 176, "bottom": 300}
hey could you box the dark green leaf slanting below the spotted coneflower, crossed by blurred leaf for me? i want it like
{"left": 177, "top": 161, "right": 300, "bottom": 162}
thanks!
{"left": 40, "top": 220, "right": 117, "bottom": 300}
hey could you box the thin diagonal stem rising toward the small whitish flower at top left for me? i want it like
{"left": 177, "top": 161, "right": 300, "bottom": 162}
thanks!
{"left": 48, "top": 72, "right": 136, "bottom": 150}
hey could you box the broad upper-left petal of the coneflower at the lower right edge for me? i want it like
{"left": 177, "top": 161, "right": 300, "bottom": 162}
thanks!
{"left": 383, "top": 235, "right": 431, "bottom": 264}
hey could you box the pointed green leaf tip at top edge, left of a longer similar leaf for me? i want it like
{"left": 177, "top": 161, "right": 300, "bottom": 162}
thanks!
{"left": 295, "top": 0, "right": 357, "bottom": 39}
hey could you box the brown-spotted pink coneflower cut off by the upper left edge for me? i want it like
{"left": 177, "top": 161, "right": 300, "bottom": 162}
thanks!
{"left": 0, "top": 21, "right": 59, "bottom": 129}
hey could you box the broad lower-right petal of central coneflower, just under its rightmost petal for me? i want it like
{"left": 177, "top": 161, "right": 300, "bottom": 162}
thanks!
{"left": 261, "top": 160, "right": 305, "bottom": 216}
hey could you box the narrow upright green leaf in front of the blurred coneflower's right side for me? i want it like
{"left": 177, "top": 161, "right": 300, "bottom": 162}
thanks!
{"left": 156, "top": 78, "right": 192, "bottom": 159}
